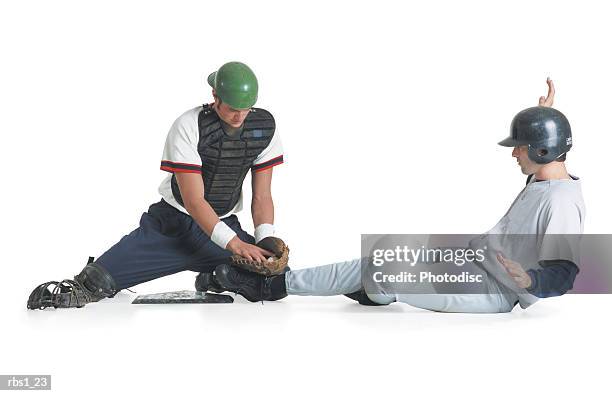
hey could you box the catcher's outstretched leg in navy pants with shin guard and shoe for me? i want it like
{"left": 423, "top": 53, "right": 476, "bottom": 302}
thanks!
{"left": 28, "top": 200, "right": 253, "bottom": 309}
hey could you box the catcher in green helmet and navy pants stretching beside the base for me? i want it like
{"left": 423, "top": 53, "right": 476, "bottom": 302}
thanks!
{"left": 27, "top": 62, "right": 288, "bottom": 309}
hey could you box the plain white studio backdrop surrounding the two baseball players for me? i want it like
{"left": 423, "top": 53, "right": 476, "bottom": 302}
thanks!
{"left": 0, "top": 0, "right": 612, "bottom": 394}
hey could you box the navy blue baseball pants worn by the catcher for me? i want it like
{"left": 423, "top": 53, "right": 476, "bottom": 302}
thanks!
{"left": 96, "top": 199, "right": 255, "bottom": 290}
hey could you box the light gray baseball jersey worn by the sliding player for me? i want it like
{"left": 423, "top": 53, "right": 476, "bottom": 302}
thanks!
{"left": 470, "top": 176, "right": 585, "bottom": 308}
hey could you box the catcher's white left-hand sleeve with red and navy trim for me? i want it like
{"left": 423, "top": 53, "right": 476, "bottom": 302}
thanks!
{"left": 160, "top": 113, "right": 202, "bottom": 173}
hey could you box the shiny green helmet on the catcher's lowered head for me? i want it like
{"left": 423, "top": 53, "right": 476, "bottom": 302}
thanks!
{"left": 208, "top": 62, "right": 259, "bottom": 109}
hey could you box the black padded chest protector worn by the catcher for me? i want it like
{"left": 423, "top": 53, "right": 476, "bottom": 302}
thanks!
{"left": 171, "top": 104, "right": 276, "bottom": 216}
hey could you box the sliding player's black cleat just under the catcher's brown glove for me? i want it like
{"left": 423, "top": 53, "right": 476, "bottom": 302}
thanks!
{"left": 215, "top": 264, "right": 287, "bottom": 302}
